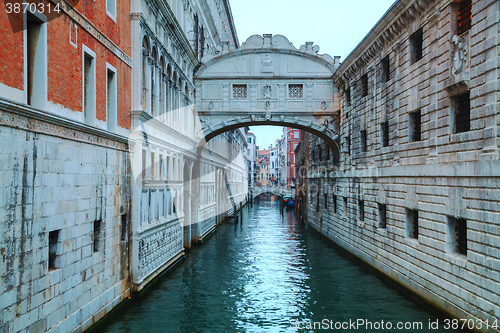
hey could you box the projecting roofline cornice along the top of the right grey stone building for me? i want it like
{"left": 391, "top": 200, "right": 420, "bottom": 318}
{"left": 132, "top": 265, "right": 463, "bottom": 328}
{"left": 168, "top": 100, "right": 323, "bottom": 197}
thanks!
{"left": 334, "top": 0, "right": 435, "bottom": 86}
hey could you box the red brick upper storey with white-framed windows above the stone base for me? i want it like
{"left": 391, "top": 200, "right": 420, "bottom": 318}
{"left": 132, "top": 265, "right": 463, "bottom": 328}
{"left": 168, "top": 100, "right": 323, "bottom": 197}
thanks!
{"left": 0, "top": 0, "right": 132, "bottom": 134}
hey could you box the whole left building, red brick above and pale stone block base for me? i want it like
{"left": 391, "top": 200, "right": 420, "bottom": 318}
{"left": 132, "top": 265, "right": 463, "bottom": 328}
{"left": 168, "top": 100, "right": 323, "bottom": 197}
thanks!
{"left": 0, "top": 1, "right": 132, "bottom": 332}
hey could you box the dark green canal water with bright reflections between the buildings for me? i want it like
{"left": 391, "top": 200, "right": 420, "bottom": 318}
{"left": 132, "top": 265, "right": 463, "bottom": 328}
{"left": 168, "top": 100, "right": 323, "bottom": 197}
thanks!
{"left": 99, "top": 196, "right": 456, "bottom": 333}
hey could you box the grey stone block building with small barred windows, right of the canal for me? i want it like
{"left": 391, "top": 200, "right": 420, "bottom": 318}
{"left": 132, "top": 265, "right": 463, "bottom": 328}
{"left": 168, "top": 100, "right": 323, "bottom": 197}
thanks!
{"left": 297, "top": 0, "right": 500, "bottom": 332}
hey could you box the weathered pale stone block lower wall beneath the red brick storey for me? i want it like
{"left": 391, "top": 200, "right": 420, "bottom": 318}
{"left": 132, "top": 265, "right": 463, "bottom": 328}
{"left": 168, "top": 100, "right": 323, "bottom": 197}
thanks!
{"left": 0, "top": 103, "right": 130, "bottom": 332}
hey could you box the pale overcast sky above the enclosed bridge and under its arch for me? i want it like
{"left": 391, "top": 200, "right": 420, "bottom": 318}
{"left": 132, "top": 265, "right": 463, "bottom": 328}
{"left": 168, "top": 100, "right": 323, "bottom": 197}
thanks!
{"left": 230, "top": 0, "right": 394, "bottom": 149}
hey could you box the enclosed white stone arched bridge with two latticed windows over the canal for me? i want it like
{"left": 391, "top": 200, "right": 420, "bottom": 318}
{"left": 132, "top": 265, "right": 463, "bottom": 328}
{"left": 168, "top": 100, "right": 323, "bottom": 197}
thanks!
{"left": 194, "top": 34, "right": 340, "bottom": 151}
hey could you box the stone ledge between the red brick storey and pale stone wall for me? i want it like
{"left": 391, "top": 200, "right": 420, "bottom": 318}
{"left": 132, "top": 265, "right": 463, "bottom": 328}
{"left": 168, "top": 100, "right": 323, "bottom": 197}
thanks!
{"left": 0, "top": 99, "right": 129, "bottom": 151}
